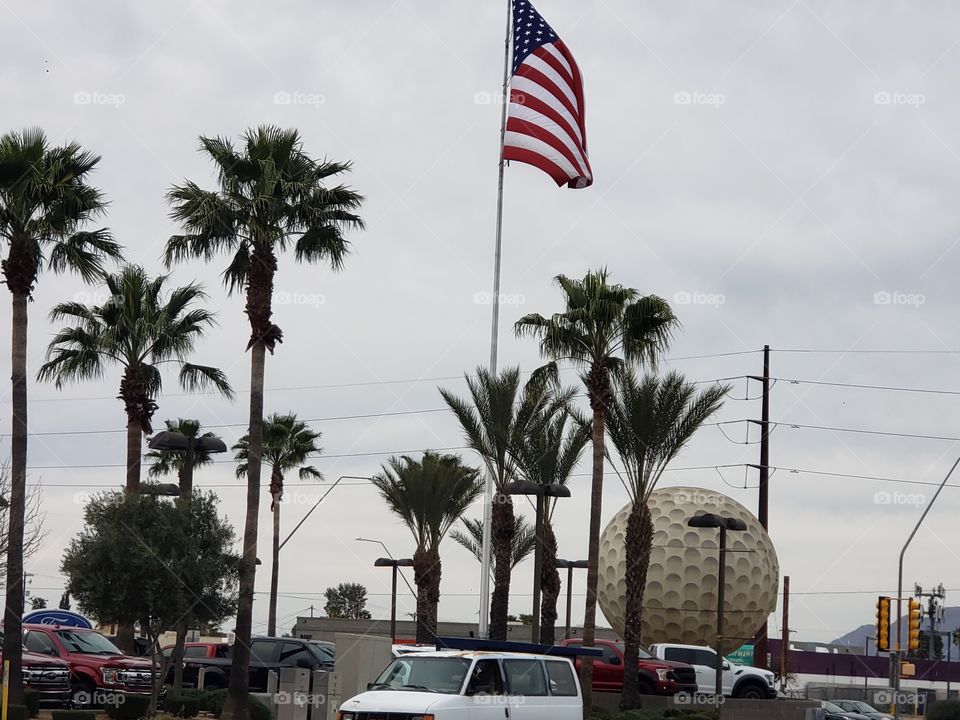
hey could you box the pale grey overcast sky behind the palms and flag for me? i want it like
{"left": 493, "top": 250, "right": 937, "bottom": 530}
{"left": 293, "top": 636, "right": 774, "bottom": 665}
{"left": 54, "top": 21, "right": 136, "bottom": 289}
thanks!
{"left": 0, "top": 0, "right": 960, "bottom": 640}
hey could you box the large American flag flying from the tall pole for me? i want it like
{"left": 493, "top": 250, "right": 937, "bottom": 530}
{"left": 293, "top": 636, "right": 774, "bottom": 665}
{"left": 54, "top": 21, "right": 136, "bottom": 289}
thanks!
{"left": 503, "top": 0, "right": 593, "bottom": 188}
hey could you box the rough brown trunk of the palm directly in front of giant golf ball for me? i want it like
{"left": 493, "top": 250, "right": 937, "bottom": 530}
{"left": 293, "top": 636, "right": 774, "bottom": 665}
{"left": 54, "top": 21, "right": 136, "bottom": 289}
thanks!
{"left": 620, "top": 503, "right": 653, "bottom": 710}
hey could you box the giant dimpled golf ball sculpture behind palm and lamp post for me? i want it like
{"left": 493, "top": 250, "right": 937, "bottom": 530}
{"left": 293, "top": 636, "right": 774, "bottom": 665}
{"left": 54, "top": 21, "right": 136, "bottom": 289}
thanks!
{"left": 597, "top": 487, "right": 780, "bottom": 652}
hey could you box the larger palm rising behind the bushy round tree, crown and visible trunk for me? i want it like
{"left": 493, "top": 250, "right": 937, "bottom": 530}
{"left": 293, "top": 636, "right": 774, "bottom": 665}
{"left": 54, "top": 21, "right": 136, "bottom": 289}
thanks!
{"left": 37, "top": 265, "right": 233, "bottom": 493}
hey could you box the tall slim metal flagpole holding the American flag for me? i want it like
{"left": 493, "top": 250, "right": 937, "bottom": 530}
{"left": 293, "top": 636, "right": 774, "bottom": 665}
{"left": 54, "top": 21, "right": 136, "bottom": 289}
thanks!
{"left": 480, "top": 0, "right": 513, "bottom": 638}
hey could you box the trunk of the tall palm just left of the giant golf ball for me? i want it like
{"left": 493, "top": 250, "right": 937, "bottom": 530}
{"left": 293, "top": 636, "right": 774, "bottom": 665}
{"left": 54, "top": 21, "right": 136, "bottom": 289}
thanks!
{"left": 580, "top": 365, "right": 610, "bottom": 720}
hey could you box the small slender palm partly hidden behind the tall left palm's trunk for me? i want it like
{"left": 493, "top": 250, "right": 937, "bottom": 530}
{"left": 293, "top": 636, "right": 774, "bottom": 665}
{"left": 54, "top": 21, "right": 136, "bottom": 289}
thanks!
{"left": 233, "top": 412, "right": 323, "bottom": 637}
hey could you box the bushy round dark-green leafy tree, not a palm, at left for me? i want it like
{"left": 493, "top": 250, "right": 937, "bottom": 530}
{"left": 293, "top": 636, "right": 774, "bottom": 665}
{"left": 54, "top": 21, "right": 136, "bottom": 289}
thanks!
{"left": 61, "top": 492, "right": 239, "bottom": 700}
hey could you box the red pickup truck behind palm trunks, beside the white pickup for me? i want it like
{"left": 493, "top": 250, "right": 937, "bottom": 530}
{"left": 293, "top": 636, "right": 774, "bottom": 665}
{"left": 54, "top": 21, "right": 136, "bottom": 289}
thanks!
{"left": 561, "top": 638, "right": 697, "bottom": 695}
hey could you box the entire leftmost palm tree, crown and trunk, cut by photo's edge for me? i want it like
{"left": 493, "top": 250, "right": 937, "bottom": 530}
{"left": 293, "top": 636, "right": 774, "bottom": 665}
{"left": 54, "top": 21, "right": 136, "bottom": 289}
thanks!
{"left": 0, "top": 128, "right": 121, "bottom": 705}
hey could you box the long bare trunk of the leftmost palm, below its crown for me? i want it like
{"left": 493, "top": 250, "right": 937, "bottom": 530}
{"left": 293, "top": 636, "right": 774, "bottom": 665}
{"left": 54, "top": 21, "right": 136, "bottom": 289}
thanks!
{"left": 3, "top": 288, "right": 28, "bottom": 705}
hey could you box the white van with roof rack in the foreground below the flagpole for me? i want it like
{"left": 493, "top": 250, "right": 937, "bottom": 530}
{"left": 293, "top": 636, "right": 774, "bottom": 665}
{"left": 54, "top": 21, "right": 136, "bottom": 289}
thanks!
{"left": 337, "top": 650, "right": 583, "bottom": 720}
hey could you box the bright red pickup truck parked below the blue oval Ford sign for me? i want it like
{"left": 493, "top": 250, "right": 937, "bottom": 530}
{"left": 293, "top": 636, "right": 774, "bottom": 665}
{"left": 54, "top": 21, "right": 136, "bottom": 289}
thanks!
{"left": 23, "top": 624, "right": 152, "bottom": 708}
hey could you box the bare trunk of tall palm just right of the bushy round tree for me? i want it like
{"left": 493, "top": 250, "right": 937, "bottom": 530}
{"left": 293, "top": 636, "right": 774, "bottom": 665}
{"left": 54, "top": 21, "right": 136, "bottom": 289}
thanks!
{"left": 220, "top": 342, "right": 267, "bottom": 720}
